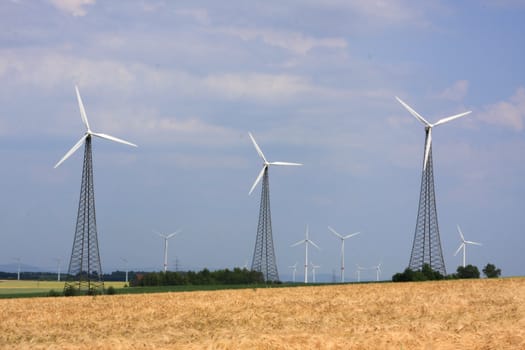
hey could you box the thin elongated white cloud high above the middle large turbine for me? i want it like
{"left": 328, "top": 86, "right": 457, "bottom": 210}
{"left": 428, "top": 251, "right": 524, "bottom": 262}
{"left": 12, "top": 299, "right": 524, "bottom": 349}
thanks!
{"left": 219, "top": 27, "right": 348, "bottom": 55}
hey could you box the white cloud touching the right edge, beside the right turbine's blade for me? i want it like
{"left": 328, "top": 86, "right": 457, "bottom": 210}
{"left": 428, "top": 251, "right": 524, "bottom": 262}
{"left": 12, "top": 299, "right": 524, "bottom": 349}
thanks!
{"left": 479, "top": 87, "right": 525, "bottom": 131}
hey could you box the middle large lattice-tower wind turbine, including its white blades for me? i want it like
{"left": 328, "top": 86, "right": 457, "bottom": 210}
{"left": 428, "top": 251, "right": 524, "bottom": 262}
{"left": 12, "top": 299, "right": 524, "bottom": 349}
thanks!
{"left": 248, "top": 133, "right": 302, "bottom": 281}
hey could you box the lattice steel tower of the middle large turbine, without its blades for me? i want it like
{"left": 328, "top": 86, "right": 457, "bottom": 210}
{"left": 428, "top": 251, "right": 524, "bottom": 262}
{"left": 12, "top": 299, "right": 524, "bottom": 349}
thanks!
{"left": 252, "top": 168, "right": 279, "bottom": 281}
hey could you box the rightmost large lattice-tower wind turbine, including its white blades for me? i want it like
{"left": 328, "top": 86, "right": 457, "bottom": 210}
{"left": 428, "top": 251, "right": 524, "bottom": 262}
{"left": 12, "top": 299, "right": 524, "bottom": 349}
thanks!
{"left": 396, "top": 97, "right": 471, "bottom": 275}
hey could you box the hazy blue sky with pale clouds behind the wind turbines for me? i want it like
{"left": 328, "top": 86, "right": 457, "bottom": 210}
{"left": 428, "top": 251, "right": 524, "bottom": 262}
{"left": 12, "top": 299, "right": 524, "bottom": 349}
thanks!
{"left": 0, "top": 0, "right": 525, "bottom": 280}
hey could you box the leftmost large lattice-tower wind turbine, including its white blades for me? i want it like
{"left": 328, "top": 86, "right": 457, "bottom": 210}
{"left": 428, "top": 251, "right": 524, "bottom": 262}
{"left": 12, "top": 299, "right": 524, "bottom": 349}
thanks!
{"left": 55, "top": 86, "right": 137, "bottom": 291}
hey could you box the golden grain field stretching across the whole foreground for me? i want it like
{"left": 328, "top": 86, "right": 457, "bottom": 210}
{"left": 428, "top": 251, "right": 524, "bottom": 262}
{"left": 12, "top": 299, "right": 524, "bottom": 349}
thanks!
{"left": 0, "top": 278, "right": 525, "bottom": 349}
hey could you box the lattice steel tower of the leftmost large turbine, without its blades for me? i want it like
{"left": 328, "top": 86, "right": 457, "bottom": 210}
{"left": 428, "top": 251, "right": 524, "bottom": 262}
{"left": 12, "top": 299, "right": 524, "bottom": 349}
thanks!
{"left": 65, "top": 136, "right": 104, "bottom": 291}
